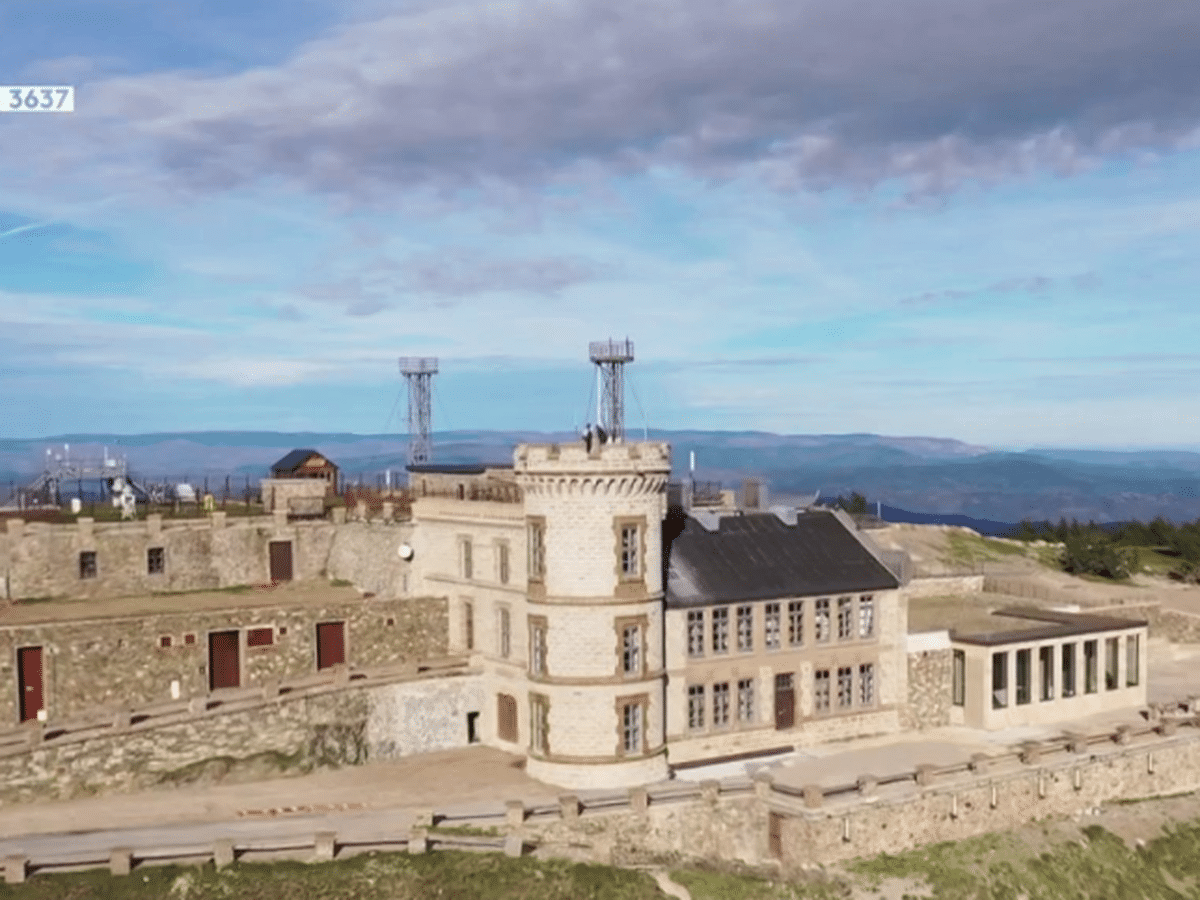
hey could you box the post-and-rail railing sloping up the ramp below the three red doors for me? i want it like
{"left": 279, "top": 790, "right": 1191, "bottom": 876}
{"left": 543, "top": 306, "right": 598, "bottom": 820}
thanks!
{"left": 0, "top": 656, "right": 469, "bottom": 757}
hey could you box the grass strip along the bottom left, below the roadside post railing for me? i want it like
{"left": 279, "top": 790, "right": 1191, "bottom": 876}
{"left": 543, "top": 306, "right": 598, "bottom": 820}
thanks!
{"left": 0, "top": 851, "right": 664, "bottom": 900}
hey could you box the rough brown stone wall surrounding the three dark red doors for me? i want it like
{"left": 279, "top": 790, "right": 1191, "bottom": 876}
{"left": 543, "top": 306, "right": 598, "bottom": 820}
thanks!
{"left": 0, "top": 595, "right": 448, "bottom": 725}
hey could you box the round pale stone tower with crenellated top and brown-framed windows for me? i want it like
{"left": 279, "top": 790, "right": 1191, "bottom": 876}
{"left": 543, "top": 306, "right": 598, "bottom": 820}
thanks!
{"left": 514, "top": 442, "right": 671, "bottom": 788}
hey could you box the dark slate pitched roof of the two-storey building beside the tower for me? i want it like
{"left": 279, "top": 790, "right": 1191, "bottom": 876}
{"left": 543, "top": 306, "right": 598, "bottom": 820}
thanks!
{"left": 664, "top": 511, "right": 900, "bottom": 607}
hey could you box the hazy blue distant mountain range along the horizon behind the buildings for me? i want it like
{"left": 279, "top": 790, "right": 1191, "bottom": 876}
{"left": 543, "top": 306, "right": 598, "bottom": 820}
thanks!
{"left": 0, "top": 430, "right": 1200, "bottom": 533}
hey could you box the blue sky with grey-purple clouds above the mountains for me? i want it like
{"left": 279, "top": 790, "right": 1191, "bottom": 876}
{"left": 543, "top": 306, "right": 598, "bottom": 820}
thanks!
{"left": 0, "top": 0, "right": 1200, "bottom": 449}
